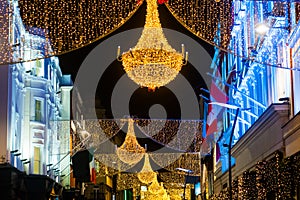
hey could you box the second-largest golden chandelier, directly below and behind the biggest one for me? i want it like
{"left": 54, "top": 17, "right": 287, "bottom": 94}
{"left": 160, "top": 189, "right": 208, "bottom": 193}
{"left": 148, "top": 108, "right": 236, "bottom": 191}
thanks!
{"left": 116, "top": 119, "right": 146, "bottom": 165}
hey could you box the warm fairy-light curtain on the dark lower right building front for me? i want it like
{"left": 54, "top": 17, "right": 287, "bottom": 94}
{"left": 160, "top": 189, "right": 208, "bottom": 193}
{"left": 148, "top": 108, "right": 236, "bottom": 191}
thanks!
{"left": 211, "top": 151, "right": 300, "bottom": 200}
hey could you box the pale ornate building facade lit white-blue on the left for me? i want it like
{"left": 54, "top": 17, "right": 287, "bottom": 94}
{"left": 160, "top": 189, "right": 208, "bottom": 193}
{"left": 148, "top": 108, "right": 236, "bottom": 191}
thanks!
{"left": 0, "top": 1, "right": 72, "bottom": 196}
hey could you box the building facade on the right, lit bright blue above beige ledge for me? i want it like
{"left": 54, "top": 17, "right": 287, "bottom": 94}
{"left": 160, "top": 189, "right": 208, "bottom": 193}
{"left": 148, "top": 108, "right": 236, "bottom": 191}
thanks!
{"left": 206, "top": 1, "right": 300, "bottom": 199}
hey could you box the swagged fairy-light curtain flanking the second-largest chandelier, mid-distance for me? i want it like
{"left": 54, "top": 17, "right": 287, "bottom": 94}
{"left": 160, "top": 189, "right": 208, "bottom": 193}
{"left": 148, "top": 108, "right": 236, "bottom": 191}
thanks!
{"left": 74, "top": 119, "right": 203, "bottom": 152}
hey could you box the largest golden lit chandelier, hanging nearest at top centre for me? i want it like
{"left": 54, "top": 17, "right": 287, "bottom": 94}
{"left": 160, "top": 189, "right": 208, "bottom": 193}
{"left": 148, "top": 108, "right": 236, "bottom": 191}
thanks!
{"left": 117, "top": 0, "right": 188, "bottom": 90}
